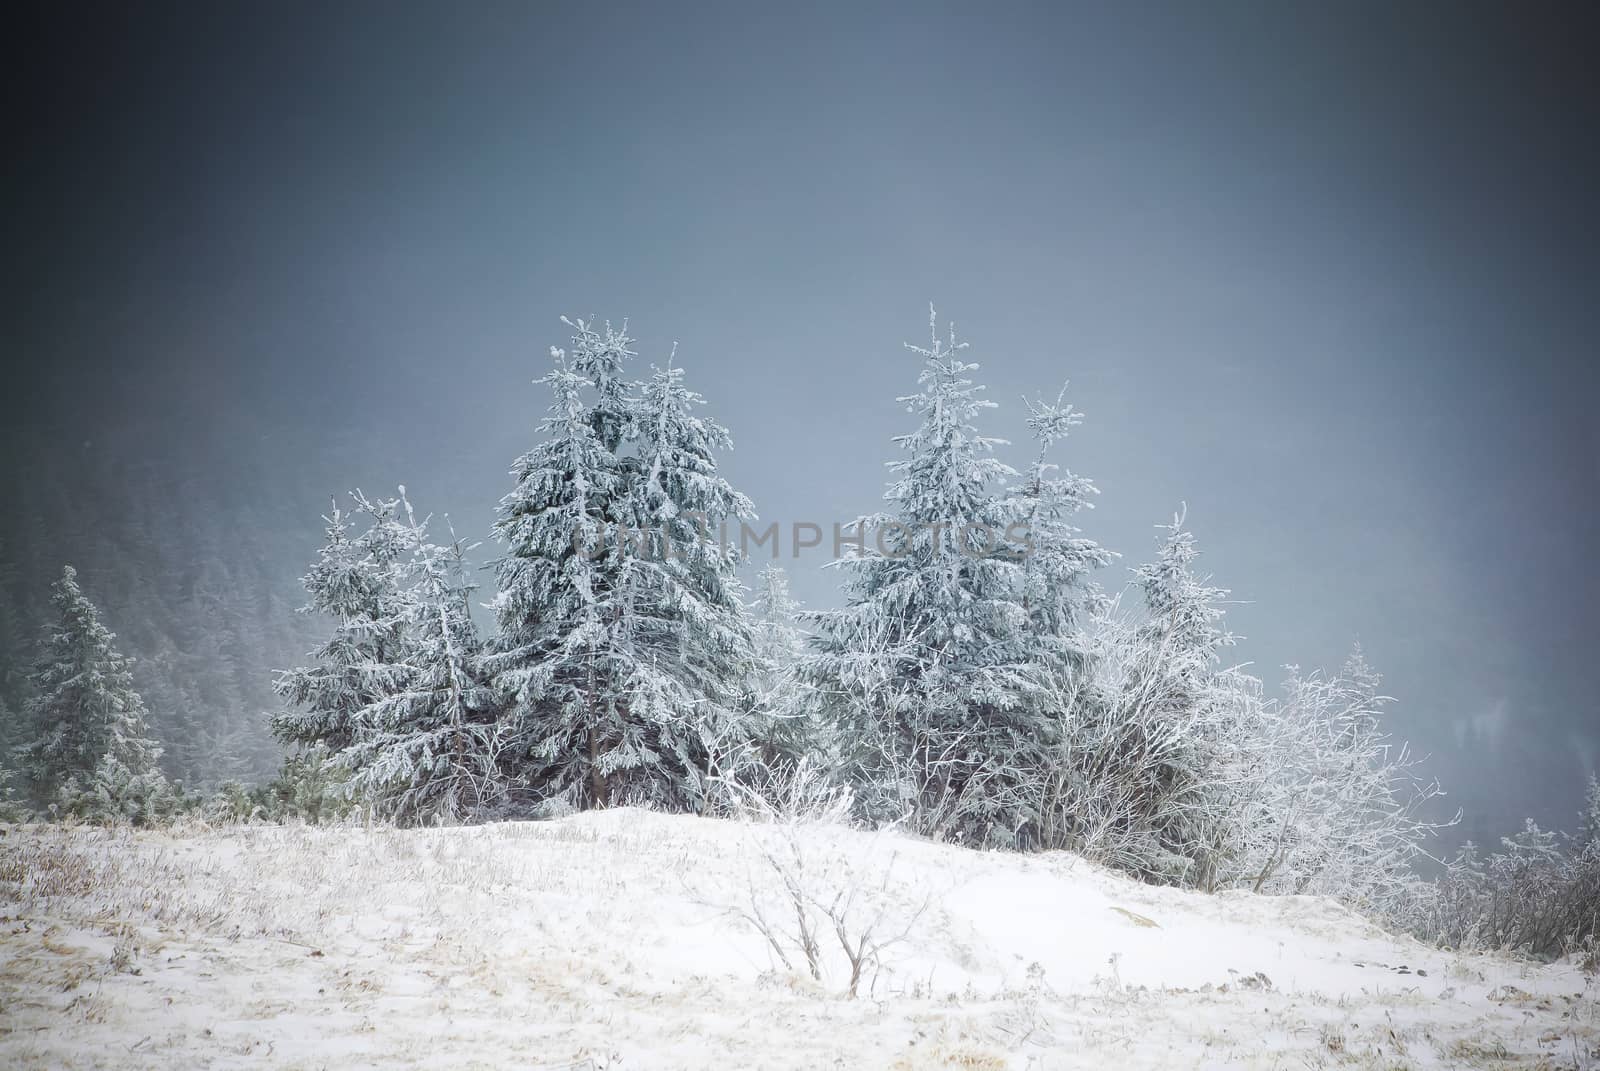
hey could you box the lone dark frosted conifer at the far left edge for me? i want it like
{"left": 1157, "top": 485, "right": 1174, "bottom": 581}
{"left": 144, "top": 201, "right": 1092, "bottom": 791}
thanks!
{"left": 19, "top": 565, "right": 162, "bottom": 805}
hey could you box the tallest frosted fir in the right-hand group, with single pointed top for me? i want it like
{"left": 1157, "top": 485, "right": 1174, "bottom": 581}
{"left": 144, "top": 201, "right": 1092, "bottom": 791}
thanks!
{"left": 806, "top": 309, "right": 1042, "bottom": 842}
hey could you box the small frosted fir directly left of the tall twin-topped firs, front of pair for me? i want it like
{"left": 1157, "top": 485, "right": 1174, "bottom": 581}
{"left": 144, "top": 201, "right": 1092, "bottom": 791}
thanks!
{"left": 339, "top": 541, "right": 504, "bottom": 821}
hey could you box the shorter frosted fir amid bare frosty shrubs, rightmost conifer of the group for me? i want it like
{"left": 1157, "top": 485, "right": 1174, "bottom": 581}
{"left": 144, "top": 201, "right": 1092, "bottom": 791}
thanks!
{"left": 1038, "top": 515, "right": 1261, "bottom": 887}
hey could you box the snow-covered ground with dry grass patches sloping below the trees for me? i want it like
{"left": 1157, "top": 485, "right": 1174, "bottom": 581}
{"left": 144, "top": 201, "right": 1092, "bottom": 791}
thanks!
{"left": 0, "top": 810, "right": 1600, "bottom": 1069}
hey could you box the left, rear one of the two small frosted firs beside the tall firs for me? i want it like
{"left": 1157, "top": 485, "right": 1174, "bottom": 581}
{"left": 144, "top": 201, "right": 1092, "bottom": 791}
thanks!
{"left": 272, "top": 487, "right": 422, "bottom": 752}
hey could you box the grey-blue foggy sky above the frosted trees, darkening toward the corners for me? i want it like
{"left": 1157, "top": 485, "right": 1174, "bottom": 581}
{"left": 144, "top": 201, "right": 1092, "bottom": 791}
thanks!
{"left": 5, "top": 3, "right": 1600, "bottom": 834}
